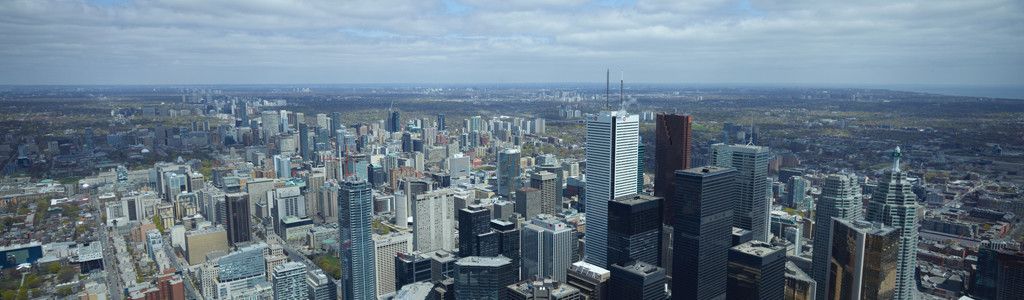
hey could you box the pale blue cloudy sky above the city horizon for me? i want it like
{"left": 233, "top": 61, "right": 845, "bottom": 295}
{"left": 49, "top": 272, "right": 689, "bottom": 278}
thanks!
{"left": 0, "top": 0, "right": 1024, "bottom": 86}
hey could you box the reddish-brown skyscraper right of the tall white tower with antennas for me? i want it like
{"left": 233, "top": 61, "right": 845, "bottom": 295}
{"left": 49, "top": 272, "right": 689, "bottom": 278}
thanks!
{"left": 654, "top": 114, "right": 693, "bottom": 224}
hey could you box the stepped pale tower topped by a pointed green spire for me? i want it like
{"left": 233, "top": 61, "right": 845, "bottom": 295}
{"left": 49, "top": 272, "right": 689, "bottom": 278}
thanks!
{"left": 867, "top": 146, "right": 918, "bottom": 299}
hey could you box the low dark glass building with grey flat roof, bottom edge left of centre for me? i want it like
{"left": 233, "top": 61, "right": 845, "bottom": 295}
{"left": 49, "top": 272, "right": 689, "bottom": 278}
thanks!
{"left": 455, "top": 256, "right": 517, "bottom": 299}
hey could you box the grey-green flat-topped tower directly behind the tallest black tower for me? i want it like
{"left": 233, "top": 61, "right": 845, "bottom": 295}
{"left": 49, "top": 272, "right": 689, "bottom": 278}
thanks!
{"left": 712, "top": 143, "right": 771, "bottom": 242}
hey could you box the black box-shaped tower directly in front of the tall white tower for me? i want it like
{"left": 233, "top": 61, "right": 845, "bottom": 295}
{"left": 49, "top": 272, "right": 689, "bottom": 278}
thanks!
{"left": 608, "top": 195, "right": 664, "bottom": 265}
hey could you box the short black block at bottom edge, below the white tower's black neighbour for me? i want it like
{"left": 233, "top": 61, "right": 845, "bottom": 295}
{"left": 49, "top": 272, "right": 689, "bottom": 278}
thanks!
{"left": 608, "top": 261, "right": 667, "bottom": 300}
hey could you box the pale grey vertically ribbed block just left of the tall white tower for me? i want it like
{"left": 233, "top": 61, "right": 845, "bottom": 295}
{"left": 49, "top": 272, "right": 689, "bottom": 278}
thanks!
{"left": 519, "top": 214, "right": 574, "bottom": 283}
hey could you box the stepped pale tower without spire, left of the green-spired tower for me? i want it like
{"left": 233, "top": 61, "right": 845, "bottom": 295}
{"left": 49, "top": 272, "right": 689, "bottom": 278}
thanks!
{"left": 811, "top": 174, "right": 862, "bottom": 295}
